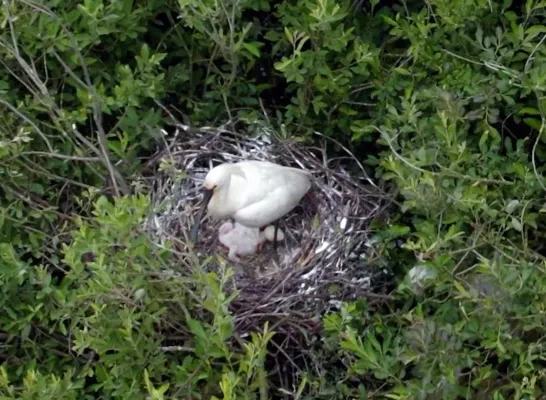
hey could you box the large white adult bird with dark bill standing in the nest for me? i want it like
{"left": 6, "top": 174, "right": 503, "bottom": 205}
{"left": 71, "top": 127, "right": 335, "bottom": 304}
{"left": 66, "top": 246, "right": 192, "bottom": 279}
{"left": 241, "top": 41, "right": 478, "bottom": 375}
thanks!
{"left": 191, "top": 161, "right": 311, "bottom": 245}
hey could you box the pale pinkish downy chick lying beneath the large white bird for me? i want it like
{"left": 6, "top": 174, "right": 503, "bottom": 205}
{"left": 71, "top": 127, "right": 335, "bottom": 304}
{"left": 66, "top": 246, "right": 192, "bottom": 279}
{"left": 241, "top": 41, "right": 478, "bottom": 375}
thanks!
{"left": 218, "top": 221, "right": 284, "bottom": 262}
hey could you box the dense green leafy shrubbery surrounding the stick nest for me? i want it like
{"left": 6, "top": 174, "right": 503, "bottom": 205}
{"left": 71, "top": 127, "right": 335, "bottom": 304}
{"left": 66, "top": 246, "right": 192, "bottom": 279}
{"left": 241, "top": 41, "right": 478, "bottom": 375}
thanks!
{"left": 0, "top": 0, "right": 546, "bottom": 400}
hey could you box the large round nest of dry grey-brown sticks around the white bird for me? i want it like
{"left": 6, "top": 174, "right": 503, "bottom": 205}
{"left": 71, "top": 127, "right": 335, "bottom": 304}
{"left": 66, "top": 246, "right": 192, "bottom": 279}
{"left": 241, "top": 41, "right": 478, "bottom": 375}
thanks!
{"left": 146, "top": 128, "right": 391, "bottom": 333}
